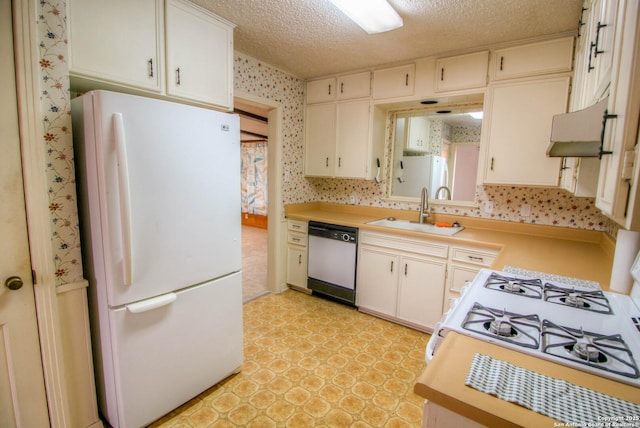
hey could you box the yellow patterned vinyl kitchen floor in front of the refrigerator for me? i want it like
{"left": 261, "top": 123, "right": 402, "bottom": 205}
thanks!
{"left": 151, "top": 290, "right": 429, "bottom": 428}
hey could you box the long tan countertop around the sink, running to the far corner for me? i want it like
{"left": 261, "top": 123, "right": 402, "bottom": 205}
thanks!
{"left": 285, "top": 203, "right": 615, "bottom": 290}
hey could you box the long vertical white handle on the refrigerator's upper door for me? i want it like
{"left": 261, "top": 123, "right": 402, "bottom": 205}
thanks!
{"left": 112, "top": 113, "right": 133, "bottom": 285}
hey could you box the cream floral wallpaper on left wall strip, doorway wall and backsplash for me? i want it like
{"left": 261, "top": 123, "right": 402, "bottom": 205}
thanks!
{"left": 33, "top": 4, "right": 615, "bottom": 285}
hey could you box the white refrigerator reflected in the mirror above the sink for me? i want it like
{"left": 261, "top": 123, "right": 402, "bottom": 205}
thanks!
{"left": 393, "top": 155, "right": 449, "bottom": 198}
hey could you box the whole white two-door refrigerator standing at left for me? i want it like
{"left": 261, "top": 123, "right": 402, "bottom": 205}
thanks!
{"left": 72, "top": 91, "right": 243, "bottom": 428}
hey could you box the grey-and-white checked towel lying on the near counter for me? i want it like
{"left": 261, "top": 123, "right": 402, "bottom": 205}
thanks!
{"left": 464, "top": 353, "right": 640, "bottom": 427}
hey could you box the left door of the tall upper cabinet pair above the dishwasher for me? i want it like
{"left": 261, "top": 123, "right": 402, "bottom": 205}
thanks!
{"left": 304, "top": 103, "right": 336, "bottom": 177}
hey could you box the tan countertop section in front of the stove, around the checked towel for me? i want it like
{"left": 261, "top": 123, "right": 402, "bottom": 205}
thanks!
{"left": 414, "top": 332, "right": 640, "bottom": 428}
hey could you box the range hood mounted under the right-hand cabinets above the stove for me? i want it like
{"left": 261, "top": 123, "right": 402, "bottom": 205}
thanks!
{"left": 547, "top": 97, "right": 609, "bottom": 157}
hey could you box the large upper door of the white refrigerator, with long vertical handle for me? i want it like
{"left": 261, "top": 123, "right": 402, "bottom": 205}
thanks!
{"left": 85, "top": 91, "right": 241, "bottom": 307}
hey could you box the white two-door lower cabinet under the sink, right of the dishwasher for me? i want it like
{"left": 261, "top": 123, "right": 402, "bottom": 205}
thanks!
{"left": 356, "top": 231, "right": 448, "bottom": 331}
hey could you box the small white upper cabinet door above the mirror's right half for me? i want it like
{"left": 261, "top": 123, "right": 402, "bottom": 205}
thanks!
{"left": 435, "top": 51, "right": 489, "bottom": 92}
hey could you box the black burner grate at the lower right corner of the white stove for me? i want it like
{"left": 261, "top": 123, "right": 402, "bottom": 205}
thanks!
{"left": 542, "top": 319, "right": 640, "bottom": 379}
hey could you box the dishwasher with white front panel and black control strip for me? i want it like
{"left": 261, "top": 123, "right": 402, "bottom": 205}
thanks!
{"left": 307, "top": 221, "right": 358, "bottom": 306}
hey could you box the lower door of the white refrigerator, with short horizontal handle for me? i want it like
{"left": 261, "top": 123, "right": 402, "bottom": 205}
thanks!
{"left": 99, "top": 273, "right": 243, "bottom": 427}
